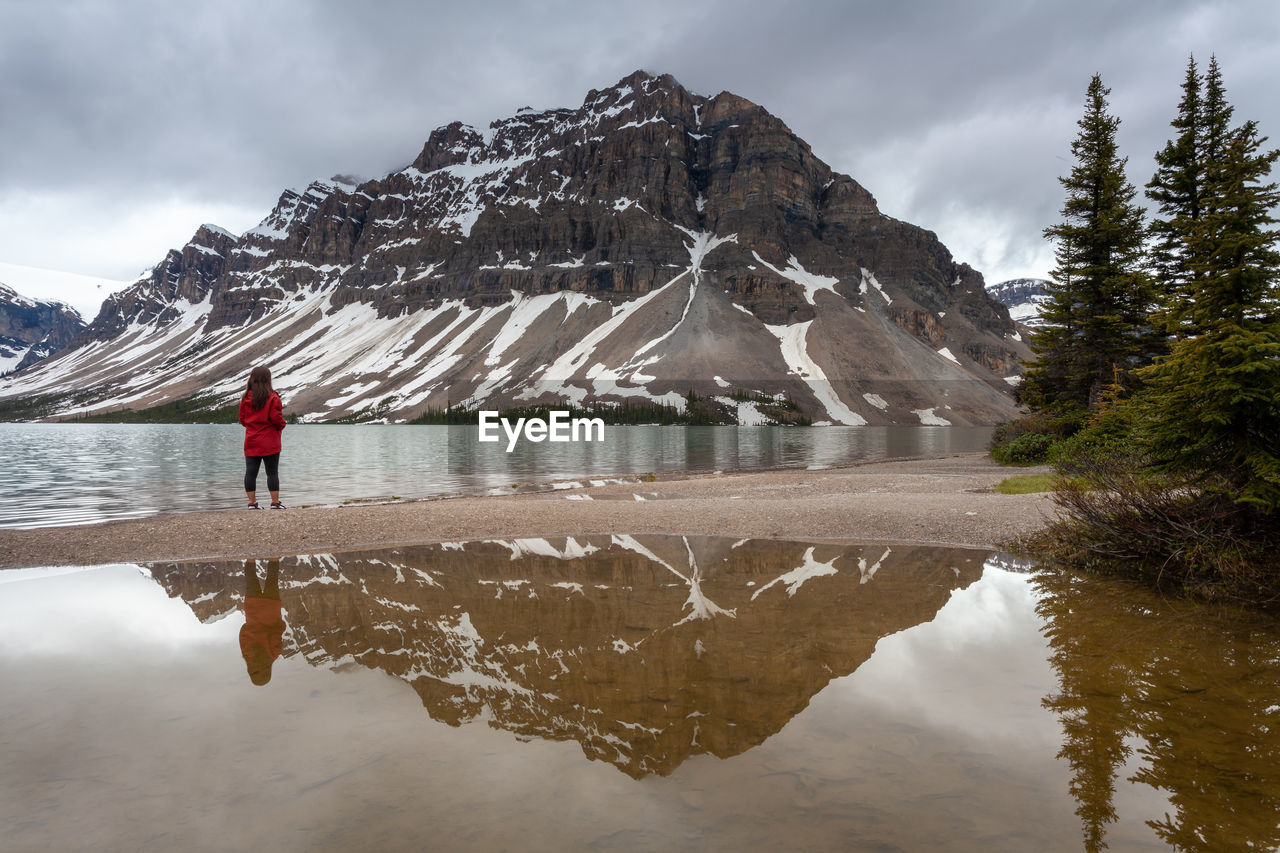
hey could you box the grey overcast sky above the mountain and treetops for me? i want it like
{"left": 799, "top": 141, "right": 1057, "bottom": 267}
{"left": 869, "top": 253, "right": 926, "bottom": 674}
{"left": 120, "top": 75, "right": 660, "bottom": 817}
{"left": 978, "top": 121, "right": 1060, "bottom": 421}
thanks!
{"left": 0, "top": 0, "right": 1280, "bottom": 302}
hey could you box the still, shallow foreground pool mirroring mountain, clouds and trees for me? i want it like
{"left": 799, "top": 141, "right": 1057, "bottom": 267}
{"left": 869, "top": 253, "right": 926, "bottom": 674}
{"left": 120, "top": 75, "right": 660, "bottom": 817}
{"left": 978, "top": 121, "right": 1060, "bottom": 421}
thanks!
{"left": 0, "top": 535, "right": 1280, "bottom": 853}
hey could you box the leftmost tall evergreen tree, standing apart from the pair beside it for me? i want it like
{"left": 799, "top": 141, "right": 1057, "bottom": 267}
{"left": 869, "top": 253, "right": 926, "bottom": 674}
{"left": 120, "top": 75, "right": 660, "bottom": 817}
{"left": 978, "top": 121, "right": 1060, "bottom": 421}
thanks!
{"left": 1021, "top": 74, "right": 1151, "bottom": 415}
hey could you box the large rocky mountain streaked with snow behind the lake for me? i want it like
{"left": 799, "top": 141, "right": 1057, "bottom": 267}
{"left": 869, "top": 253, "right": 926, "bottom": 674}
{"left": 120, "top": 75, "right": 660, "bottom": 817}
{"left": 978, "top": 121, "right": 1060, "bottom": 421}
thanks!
{"left": 0, "top": 72, "right": 1028, "bottom": 424}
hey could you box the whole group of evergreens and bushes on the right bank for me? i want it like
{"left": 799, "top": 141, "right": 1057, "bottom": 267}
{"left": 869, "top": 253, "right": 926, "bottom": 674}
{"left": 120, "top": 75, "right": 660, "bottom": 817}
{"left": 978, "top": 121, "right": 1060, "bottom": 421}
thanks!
{"left": 992, "top": 56, "right": 1280, "bottom": 605}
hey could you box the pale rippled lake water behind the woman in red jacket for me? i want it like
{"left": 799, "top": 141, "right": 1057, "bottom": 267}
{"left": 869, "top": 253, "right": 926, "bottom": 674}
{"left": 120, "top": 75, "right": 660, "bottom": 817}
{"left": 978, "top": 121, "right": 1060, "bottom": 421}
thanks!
{"left": 0, "top": 424, "right": 991, "bottom": 528}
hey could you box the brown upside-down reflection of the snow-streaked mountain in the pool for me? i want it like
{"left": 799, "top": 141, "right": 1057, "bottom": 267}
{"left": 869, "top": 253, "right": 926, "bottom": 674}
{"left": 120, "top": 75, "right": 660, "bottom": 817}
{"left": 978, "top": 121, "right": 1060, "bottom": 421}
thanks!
{"left": 152, "top": 535, "right": 983, "bottom": 777}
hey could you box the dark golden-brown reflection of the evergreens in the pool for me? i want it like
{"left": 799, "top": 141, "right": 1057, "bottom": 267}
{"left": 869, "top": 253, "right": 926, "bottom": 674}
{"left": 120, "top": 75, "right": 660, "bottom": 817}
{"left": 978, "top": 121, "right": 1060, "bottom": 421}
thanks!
{"left": 1034, "top": 563, "right": 1280, "bottom": 853}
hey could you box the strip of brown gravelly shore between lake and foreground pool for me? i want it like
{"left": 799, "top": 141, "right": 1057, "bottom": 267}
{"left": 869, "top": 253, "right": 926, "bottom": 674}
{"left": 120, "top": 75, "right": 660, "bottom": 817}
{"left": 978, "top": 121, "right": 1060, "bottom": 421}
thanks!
{"left": 0, "top": 453, "right": 1053, "bottom": 569}
